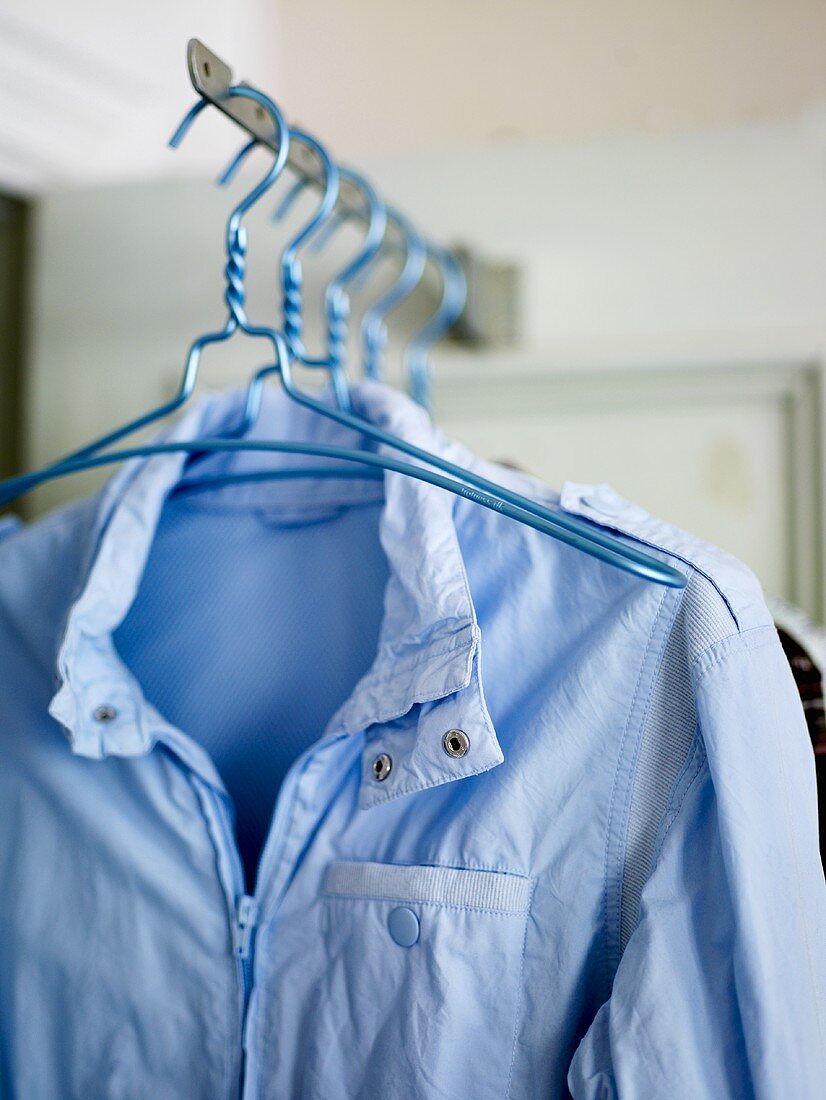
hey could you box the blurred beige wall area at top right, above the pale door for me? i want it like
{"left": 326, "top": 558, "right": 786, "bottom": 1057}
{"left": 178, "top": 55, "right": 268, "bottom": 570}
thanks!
{"left": 277, "top": 0, "right": 826, "bottom": 151}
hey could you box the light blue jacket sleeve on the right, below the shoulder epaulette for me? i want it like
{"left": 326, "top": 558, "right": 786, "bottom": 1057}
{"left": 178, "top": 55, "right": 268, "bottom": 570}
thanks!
{"left": 568, "top": 627, "right": 826, "bottom": 1100}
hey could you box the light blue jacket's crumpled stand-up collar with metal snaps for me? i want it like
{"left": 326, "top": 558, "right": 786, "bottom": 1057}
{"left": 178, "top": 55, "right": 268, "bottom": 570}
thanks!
{"left": 48, "top": 382, "right": 504, "bottom": 806}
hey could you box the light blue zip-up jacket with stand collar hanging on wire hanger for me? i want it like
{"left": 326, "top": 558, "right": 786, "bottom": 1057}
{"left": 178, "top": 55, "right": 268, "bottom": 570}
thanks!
{"left": 0, "top": 383, "right": 826, "bottom": 1100}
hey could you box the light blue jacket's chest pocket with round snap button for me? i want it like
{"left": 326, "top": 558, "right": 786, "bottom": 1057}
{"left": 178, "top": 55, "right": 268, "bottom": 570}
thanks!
{"left": 311, "top": 862, "right": 531, "bottom": 1100}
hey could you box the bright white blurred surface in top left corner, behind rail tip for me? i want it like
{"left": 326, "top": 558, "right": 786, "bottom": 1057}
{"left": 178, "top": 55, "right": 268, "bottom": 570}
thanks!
{"left": 0, "top": 0, "right": 276, "bottom": 191}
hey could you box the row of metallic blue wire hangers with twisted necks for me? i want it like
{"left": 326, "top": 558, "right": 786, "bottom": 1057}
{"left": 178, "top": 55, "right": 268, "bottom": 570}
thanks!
{"left": 0, "top": 40, "right": 685, "bottom": 587}
